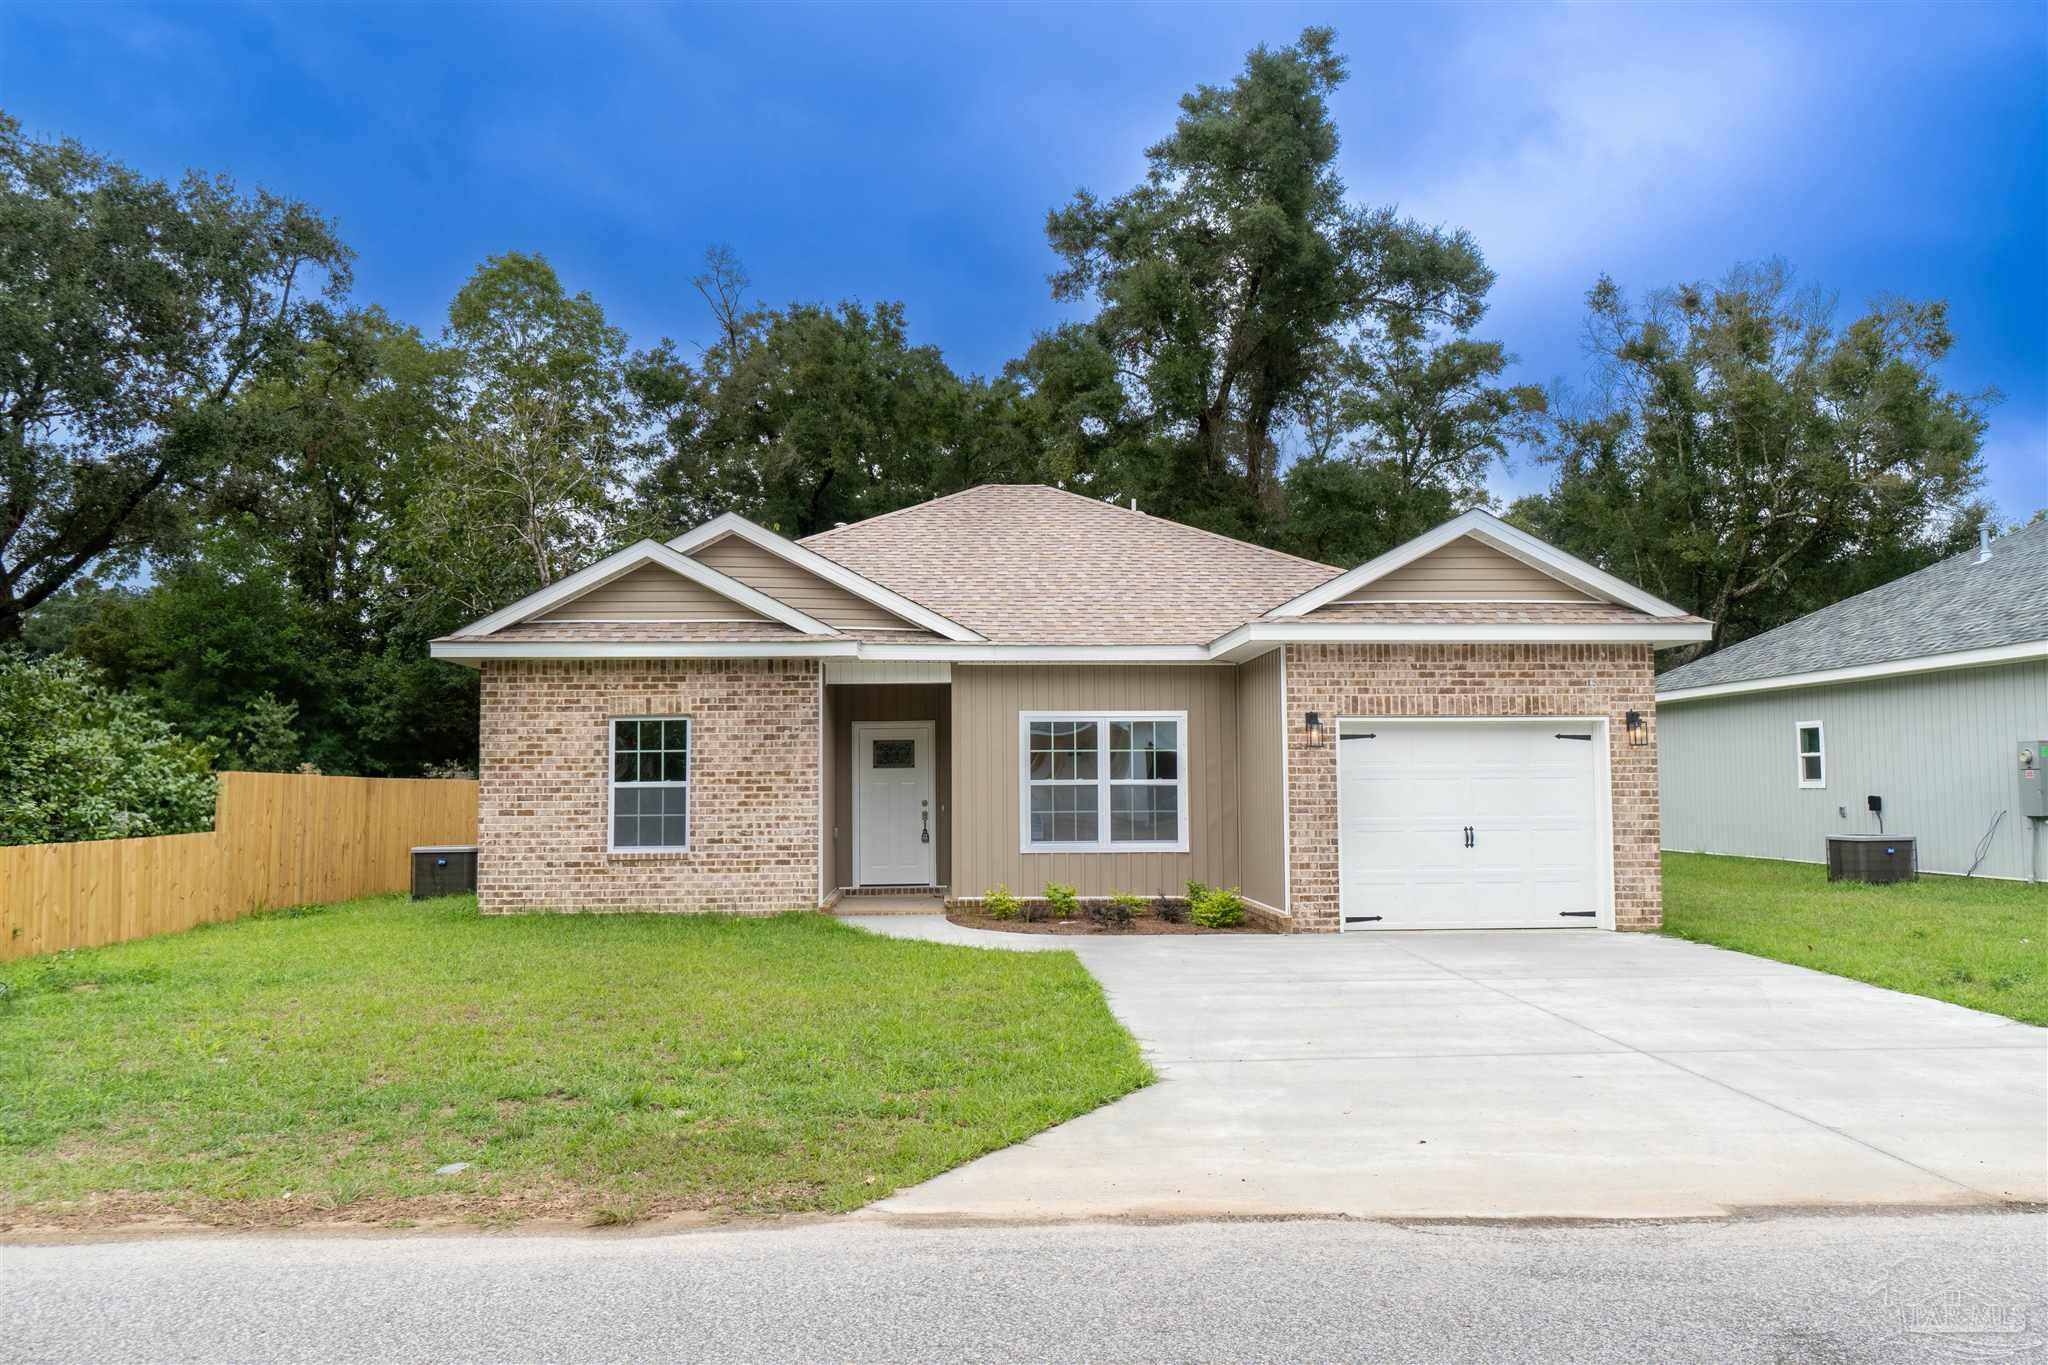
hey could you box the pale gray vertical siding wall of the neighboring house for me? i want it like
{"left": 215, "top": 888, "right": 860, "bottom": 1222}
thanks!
{"left": 1657, "top": 659, "right": 2048, "bottom": 878}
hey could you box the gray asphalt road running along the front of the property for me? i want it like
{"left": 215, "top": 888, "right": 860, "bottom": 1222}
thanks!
{"left": 0, "top": 1212, "right": 2048, "bottom": 1365}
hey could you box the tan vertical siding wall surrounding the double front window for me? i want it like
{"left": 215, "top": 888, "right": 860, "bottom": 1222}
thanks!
{"left": 952, "top": 665, "right": 1239, "bottom": 896}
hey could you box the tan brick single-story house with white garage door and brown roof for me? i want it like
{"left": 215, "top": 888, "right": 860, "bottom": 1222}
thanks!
{"left": 432, "top": 485, "right": 1710, "bottom": 931}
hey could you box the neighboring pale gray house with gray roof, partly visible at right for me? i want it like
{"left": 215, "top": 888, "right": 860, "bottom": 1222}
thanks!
{"left": 1657, "top": 522, "right": 2048, "bottom": 880}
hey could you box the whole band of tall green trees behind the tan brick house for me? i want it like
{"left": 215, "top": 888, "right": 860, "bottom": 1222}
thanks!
{"left": 0, "top": 29, "right": 2015, "bottom": 837}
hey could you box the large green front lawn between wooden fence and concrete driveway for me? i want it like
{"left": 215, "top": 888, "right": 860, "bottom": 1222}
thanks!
{"left": 0, "top": 896, "right": 1153, "bottom": 1224}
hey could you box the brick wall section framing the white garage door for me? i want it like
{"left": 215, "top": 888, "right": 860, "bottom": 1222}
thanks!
{"left": 1286, "top": 645, "right": 1663, "bottom": 933}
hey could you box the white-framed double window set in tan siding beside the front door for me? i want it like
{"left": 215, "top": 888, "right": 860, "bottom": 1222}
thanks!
{"left": 1018, "top": 710, "right": 1188, "bottom": 853}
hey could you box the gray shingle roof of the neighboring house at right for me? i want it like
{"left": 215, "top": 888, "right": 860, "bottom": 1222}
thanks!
{"left": 1657, "top": 522, "right": 2048, "bottom": 692}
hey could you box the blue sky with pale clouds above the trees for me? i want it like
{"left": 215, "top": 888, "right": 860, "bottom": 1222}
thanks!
{"left": 0, "top": 0, "right": 2048, "bottom": 518}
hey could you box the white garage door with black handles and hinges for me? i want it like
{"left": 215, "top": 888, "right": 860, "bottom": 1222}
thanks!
{"left": 1337, "top": 720, "right": 1606, "bottom": 929}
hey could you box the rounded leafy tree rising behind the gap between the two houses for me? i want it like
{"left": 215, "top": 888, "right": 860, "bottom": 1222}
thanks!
{"left": 1513, "top": 262, "right": 1995, "bottom": 647}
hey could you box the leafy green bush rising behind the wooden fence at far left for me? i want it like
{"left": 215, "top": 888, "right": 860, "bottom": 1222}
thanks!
{"left": 0, "top": 651, "right": 213, "bottom": 843}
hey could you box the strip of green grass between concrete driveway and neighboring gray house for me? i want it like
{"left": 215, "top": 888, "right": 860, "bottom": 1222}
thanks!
{"left": 1663, "top": 853, "right": 2048, "bottom": 1023}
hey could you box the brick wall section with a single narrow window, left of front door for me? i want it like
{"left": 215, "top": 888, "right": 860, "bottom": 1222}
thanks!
{"left": 477, "top": 659, "right": 821, "bottom": 915}
